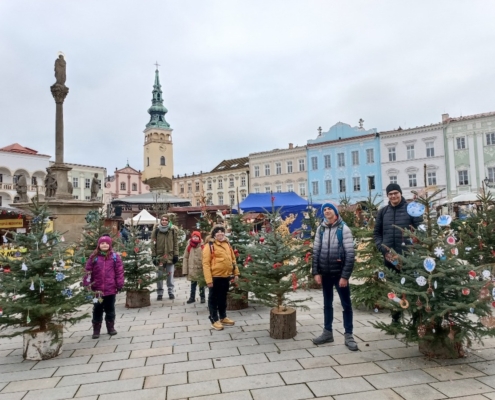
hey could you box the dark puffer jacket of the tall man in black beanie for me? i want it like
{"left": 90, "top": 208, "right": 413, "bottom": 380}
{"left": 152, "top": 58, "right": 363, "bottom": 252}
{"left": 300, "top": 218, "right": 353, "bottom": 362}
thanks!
{"left": 373, "top": 198, "right": 423, "bottom": 254}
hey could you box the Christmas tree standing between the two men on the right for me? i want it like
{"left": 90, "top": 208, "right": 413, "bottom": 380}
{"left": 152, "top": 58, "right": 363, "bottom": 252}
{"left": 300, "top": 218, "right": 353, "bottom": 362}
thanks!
{"left": 351, "top": 195, "right": 389, "bottom": 312}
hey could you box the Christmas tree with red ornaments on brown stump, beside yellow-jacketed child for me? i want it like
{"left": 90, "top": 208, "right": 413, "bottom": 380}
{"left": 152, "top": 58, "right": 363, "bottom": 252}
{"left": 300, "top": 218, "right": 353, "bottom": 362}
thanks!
{"left": 239, "top": 207, "right": 307, "bottom": 339}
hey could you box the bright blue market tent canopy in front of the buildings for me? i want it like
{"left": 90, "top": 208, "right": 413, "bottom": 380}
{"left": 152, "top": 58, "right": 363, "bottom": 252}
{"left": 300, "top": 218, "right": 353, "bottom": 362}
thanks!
{"left": 239, "top": 192, "right": 321, "bottom": 232}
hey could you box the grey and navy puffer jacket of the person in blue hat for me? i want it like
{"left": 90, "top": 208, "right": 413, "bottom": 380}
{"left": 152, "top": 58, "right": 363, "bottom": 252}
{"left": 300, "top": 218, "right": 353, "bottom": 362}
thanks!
{"left": 312, "top": 217, "right": 354, "bottom": 279}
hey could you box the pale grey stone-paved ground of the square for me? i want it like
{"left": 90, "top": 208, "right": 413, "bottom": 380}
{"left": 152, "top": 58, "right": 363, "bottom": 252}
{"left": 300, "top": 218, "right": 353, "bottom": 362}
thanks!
{"left": 0, "top": 278, "right": 495, "bottom": 400}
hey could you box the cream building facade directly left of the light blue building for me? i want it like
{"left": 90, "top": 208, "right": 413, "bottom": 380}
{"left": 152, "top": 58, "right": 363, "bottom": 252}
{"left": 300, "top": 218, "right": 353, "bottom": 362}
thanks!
{"left": 249, "top": 143, "right": 308, "bottom": 198}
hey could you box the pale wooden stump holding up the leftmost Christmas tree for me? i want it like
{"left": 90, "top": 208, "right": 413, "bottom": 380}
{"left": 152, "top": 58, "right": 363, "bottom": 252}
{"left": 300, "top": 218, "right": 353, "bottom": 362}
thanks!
{"left": 22, "top": 325, "right": 63, "bottom": 361}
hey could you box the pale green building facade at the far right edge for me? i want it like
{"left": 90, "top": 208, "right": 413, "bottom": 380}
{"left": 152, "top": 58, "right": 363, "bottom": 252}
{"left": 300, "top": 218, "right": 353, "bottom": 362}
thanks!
{"left": 442, "top": 112, "right": 495, "bottom": 199}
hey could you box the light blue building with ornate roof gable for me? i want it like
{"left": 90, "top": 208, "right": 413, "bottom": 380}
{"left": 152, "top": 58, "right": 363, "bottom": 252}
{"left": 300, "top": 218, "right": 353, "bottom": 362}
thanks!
{"left": 307, "top": 120, "right": 382, "bottom": 204}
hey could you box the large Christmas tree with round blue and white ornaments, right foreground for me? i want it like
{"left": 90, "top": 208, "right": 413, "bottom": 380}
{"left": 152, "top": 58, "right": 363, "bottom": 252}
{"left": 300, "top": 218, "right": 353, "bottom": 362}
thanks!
{"left": 375, "top": 190, "right": 495, "bottom": 358}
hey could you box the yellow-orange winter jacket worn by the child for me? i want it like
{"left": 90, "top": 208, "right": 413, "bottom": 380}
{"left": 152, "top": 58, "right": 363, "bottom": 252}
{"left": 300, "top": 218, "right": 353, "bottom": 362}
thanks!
{"left": 203, "top": 239, "right": 239, "bottom": 284}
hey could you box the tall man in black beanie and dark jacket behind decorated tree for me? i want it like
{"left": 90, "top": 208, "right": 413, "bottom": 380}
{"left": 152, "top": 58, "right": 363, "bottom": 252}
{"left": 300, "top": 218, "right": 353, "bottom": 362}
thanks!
{"left": 373, "top": 183, "right": 422, "bottom": 321}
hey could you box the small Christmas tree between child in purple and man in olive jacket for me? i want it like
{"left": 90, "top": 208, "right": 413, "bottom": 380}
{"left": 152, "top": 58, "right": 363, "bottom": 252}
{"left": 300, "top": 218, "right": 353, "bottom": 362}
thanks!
{"left": 120, "top": 226, "right": 156, "bottom": 308}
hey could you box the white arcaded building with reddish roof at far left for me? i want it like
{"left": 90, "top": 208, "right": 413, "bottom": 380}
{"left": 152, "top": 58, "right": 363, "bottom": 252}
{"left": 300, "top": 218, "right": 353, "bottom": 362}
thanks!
{"left": 0, "top": 143, "right": 50, "bottom": 207}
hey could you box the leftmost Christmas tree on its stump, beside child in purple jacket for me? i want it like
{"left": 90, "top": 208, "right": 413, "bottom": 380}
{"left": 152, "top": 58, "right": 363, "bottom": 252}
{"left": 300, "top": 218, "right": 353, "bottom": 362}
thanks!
{"left": 0, "top": 201, "right": 88, "bottom": 359}
